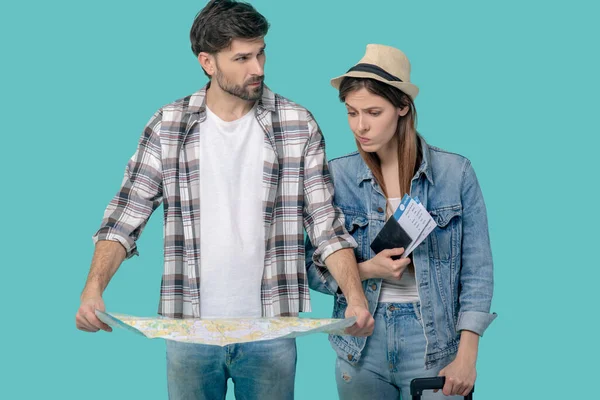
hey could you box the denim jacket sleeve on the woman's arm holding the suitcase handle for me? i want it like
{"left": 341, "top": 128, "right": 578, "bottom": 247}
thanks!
{"left": 456, "top": 161, "right": 497, "bottom": 336}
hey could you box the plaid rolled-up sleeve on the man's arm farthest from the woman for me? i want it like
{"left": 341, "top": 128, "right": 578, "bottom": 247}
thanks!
{"left": 93, "top": 111, "right": 163, "bottom": 258}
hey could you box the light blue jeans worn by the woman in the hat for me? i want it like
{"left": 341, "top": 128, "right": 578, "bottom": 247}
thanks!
{"left": 335, "top": 303, "right": 463, "bottom": 400}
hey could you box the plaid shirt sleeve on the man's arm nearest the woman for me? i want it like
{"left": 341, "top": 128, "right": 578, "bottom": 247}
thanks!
{"left": 303, "top": 114, "right": 357, "bottom": 267}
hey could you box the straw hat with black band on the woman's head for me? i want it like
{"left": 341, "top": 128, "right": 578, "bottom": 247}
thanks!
{"left": 331, "top": 44, "right": 419, "bottom": 100}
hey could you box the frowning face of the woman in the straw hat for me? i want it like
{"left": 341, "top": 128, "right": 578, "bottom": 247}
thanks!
{"left": 346, "top": 88, "right": 408, "bottom": 153}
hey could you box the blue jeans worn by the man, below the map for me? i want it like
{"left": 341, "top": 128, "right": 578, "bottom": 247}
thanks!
{"left": 166, "top": 339, "right": 296, "bottom": 400}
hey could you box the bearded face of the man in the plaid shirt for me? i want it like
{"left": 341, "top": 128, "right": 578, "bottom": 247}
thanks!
{"left": 212, "top": 38, "right": 266, "bottom": 101}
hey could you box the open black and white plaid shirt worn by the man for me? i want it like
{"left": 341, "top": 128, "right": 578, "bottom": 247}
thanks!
{"left": 94, "top": 87, "right": 356, "bottom": 318}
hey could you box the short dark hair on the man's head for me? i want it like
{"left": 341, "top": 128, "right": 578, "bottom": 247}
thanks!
{"left": 190, "top": 0, "right": 269, "bottom": 57}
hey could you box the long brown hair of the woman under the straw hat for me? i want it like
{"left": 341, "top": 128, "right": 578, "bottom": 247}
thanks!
{"left": 339, "top": 77, "right": 421, "bottom": 198}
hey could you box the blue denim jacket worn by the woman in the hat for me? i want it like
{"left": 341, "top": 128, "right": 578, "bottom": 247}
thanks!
{"left": 306, "top": 137, "right": 496, "bottom": 369}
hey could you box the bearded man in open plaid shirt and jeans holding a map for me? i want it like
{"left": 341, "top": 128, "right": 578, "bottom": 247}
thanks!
{"left": 76, "top": 0, "right": 374, "bottom": 400}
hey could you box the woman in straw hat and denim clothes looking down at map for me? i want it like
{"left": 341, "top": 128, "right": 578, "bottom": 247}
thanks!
{"left": 307, "top": 44, "right": 496, "bottom": 399}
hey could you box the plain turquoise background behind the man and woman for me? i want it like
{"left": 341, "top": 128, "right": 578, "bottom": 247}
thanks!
{"left": 0, "top": 0, "right": 600, "bottom": 400}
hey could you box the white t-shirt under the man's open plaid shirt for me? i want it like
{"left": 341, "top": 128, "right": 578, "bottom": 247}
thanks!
{"left": 199, "top": 107, "right": 265, "bottom": 318}
